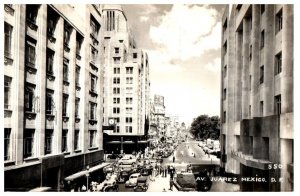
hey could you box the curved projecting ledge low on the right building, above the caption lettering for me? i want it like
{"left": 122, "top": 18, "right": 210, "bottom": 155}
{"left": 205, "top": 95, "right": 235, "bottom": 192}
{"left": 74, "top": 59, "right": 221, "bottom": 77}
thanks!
{"left": 231, "top": 151, "right": 272, "bottom": 170}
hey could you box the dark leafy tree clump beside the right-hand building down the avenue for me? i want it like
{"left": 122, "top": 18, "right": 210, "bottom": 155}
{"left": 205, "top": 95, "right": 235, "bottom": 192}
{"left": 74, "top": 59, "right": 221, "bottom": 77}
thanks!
{"left": 190, "top": 114, "right": 220, "bottom": 139}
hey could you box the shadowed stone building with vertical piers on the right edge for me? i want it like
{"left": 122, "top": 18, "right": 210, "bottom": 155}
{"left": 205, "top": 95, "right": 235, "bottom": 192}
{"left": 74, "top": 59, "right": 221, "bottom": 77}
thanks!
{"left": 220, "top": 4, "right": 294, "bottom": 191}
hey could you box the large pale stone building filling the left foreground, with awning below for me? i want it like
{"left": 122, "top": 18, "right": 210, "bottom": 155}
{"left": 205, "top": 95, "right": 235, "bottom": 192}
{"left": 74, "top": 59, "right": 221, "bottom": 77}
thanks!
{"left": 4, "top": 4, "right": 104, "bottom": 191}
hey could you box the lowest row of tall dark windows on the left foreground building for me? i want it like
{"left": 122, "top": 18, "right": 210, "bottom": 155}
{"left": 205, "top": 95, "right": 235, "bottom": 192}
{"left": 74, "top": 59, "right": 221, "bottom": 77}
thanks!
{"left": 4, "top": 128, "right": 97, "bottom": 161}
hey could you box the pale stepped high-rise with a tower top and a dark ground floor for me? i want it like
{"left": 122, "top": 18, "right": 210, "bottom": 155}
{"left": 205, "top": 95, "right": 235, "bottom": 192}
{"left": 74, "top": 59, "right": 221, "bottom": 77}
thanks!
{"left": 102, "top": 5, "right": 150, "bottom": 153}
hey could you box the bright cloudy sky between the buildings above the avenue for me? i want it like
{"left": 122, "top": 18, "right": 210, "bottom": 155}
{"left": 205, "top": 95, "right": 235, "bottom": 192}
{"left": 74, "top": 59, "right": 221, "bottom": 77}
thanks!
{"left": 122, "top": 4, "right": 225, "bottom": 124}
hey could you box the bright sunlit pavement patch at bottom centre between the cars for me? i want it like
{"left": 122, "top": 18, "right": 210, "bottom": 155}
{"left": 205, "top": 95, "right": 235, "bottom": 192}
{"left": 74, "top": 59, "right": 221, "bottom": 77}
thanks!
{"left": 147, "top": 174, "right": 178, "bottom": 192}
